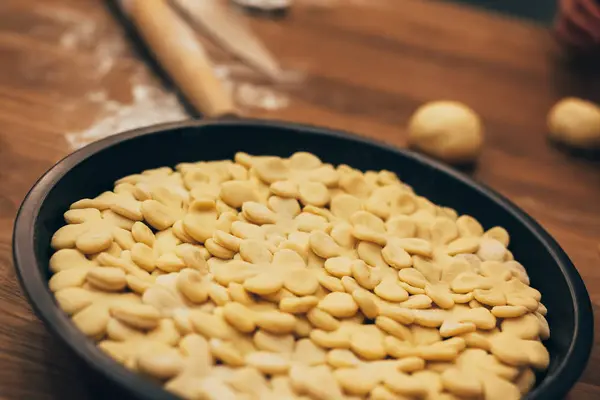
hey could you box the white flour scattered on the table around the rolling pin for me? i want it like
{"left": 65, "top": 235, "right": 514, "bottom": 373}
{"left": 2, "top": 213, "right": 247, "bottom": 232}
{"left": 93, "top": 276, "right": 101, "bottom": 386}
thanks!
{"left": 33, "top": 1, "right": 289, "bottom": 149}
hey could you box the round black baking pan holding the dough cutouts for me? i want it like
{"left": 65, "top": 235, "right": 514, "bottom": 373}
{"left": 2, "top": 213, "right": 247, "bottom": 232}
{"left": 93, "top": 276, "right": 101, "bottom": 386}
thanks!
{"left": 13, "top": 120, "right": 593, "bottom": 400}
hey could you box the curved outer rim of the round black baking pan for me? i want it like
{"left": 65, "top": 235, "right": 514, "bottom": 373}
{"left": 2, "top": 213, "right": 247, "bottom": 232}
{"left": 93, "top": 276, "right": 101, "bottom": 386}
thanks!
{"left": 12, "top": 118, "right": 593, "bottom": 400}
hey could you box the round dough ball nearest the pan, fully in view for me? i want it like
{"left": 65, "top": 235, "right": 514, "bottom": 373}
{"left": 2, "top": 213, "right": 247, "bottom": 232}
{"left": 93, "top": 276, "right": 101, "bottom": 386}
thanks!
{"left": 408, "top": 101, "right": 483, "bottom": 164}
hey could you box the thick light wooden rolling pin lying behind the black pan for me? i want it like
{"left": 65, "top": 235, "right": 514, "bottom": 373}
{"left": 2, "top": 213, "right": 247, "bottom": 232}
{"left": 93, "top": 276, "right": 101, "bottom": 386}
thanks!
{"left": 128, "top": 0, "right": 237, "bottom": 117}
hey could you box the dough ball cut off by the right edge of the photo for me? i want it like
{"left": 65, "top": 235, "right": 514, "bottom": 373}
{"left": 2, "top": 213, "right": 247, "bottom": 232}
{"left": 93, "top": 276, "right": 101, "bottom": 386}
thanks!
{"left": 548, "top": 97, "right": 600, "bottom": 149}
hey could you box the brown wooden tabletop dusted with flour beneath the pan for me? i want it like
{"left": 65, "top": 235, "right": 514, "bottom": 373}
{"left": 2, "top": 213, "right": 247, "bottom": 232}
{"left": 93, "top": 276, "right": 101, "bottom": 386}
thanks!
{"left": 0, "top": 0, "right": 600, "bottom": 400}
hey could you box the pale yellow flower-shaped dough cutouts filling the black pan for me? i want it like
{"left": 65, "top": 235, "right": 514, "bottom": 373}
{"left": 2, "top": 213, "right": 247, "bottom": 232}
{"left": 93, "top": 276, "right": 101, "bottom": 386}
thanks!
{"left": 49, "top": 152, "right": 549, "bottom": 400}
